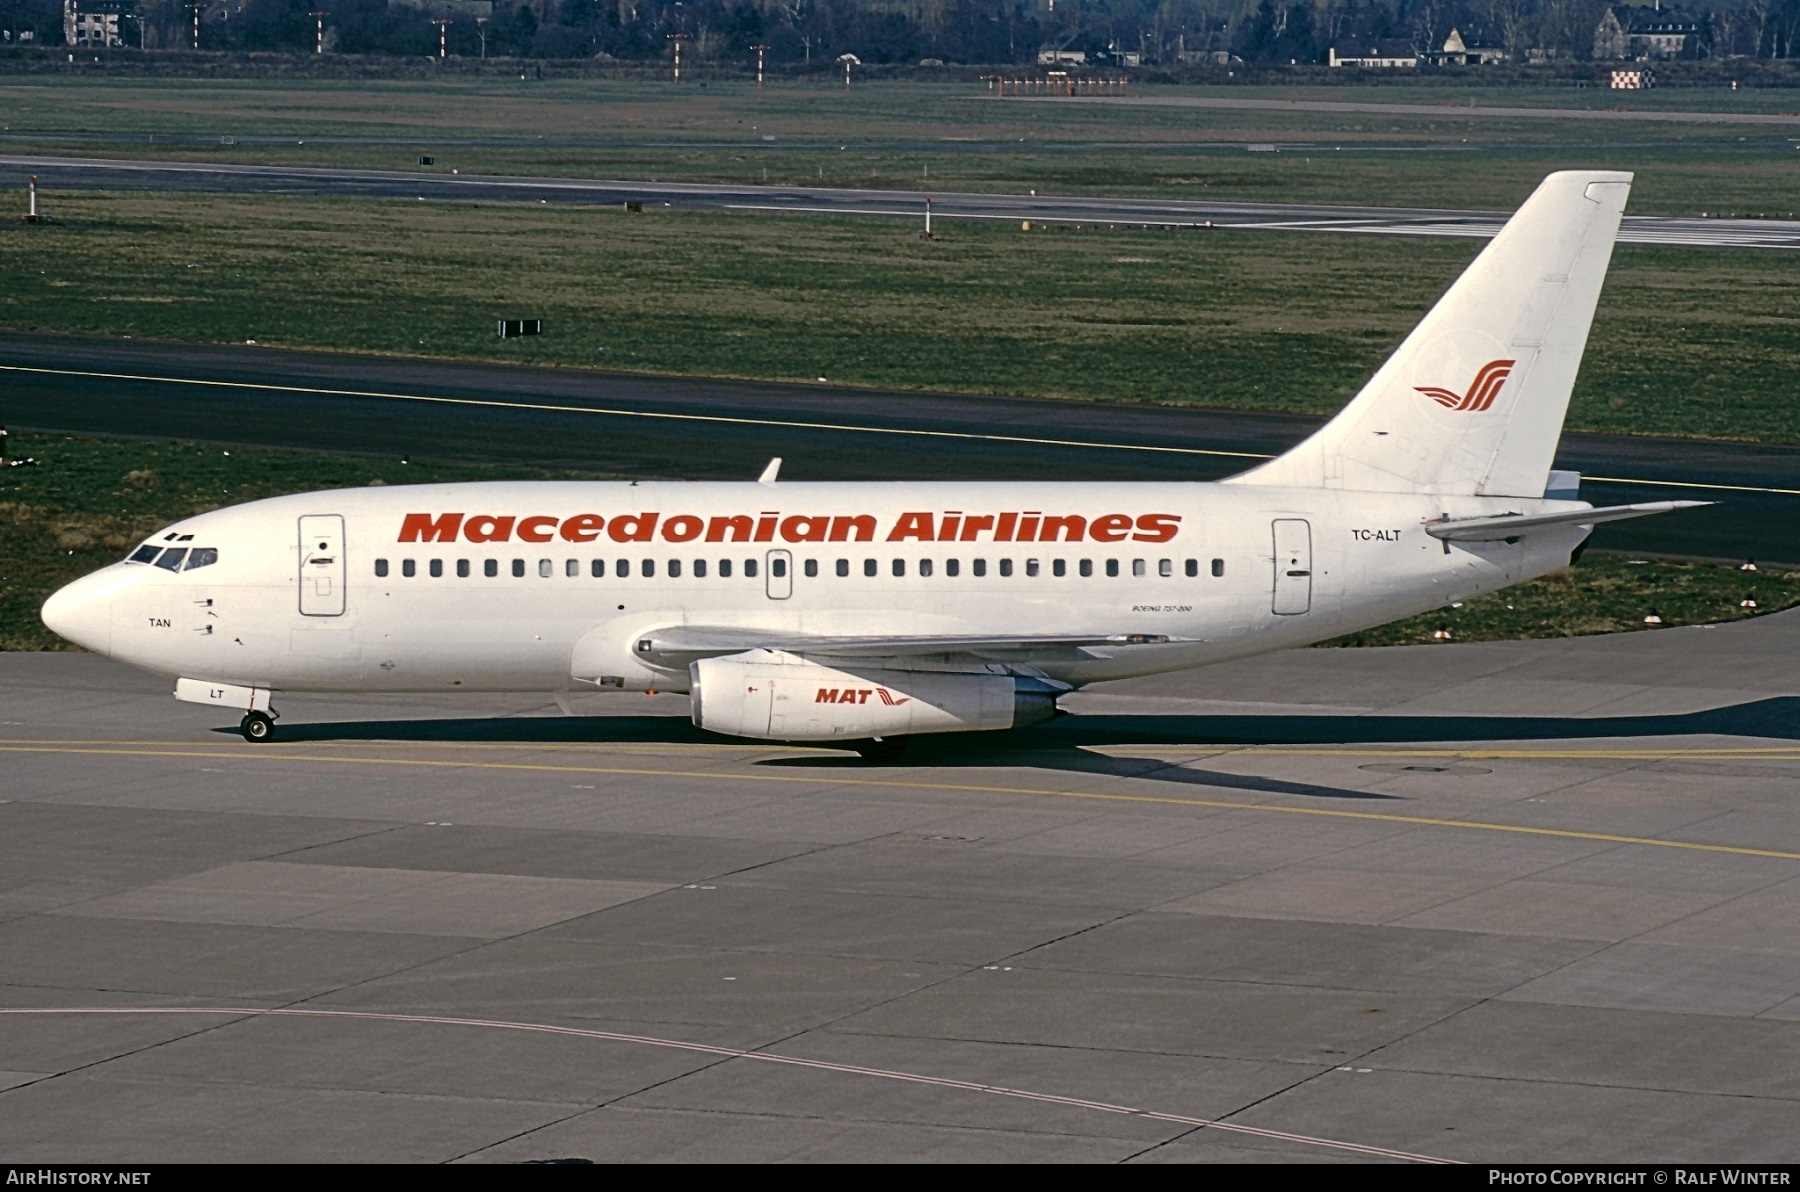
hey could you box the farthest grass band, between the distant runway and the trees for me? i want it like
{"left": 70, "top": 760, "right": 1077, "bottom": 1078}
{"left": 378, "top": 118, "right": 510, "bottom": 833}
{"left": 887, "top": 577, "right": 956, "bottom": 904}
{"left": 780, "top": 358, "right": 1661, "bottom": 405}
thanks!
{"left": 0, "top": 77, "right": 1800, "bottom": 214}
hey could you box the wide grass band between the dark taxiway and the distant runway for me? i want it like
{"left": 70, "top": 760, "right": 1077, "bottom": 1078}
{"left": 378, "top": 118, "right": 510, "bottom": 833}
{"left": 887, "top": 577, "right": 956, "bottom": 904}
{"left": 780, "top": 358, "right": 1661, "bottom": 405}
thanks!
{"left": 0, "top": 194, "right": 1800, "bottom": 443}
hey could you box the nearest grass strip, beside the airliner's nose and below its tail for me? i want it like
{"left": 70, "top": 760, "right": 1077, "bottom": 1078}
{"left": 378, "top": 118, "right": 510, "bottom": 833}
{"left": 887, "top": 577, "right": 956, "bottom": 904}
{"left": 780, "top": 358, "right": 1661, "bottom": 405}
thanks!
{"left": 10, "top": 436, "right": 1800, "bottom": 650}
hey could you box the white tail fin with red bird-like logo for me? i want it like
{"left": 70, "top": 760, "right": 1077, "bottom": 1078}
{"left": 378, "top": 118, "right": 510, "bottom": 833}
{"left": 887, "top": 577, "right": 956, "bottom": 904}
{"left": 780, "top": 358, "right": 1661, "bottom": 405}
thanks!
{"left": 1228, "top": 169, "right": 1631, "bottom": 497}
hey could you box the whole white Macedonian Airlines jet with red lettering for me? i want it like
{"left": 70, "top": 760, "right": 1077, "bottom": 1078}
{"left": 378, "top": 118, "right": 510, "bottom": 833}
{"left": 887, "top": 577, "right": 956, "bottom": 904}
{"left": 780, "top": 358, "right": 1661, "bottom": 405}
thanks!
{"left": 43, "top": 171, "right": 1701, "bottom": 756}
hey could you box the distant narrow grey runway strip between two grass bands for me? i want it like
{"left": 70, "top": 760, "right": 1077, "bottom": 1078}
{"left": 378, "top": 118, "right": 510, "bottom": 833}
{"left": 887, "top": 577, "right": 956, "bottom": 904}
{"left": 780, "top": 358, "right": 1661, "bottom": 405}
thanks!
{"left": 0, "top": 153, "right": 1800, "bottom": 250}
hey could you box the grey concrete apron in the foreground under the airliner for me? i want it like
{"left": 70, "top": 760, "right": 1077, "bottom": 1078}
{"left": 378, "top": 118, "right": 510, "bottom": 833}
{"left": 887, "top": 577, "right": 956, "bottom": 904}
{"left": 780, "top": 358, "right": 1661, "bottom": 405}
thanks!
{"left": 0, "top": 614, "right": 1800, "bottom": 1163}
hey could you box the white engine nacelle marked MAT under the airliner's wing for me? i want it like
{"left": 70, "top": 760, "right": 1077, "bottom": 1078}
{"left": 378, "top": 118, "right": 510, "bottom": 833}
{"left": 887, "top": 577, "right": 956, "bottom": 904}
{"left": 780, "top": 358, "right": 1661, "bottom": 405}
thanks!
{"left": 688, "top": 650, "right": 1060, "bottom": 740}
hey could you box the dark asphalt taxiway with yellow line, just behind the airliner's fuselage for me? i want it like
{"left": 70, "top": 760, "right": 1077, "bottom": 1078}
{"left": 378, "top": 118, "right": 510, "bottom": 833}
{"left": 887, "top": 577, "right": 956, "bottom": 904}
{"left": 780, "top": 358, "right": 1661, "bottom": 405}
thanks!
{"left": 0, "top": 333, "right": 1800, "bottom": 564}
